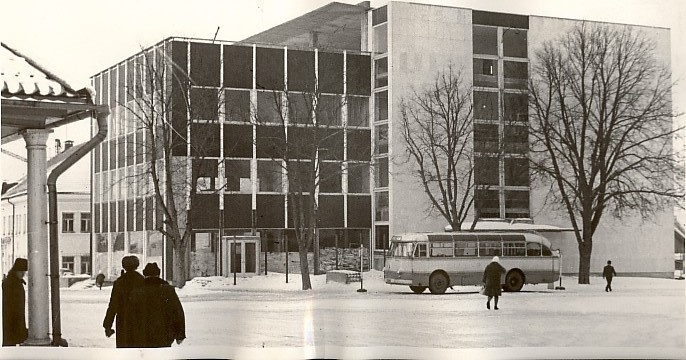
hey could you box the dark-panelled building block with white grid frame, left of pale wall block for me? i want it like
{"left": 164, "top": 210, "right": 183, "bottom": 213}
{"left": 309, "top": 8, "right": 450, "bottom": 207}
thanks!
{"left": 92, "top": 27, "right": 371, "bottom": 278}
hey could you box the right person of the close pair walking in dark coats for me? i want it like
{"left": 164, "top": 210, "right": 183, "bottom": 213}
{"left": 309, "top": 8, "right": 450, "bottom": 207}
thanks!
{"left": 129, "top": 263, "right": 186, "bottom": 348}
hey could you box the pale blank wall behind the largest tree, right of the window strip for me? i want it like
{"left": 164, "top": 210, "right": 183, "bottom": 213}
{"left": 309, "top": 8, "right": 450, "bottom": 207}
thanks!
{"left": 529, "top": 16, "right": 674, "bottom": 278}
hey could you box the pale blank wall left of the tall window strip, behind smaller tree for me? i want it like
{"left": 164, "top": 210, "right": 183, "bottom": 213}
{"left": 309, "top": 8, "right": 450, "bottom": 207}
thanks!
{"left": 388, "top": 2, "right": 472, "bottom": 236}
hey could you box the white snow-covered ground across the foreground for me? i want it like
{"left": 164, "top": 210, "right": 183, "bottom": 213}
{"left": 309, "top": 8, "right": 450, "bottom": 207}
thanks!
{"left": 0, "top": 271, "right": 686, "bottom": 358}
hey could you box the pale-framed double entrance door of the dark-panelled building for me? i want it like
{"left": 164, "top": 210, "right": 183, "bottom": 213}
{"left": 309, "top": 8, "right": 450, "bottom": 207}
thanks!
{"left": 222, "top": 236, "right": 260, "bottom": 276}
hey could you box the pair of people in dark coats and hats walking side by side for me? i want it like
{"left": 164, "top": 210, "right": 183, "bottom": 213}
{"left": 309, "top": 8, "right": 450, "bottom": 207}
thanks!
{"left": 102, "top": 255, "right": 186, "bottom": 348}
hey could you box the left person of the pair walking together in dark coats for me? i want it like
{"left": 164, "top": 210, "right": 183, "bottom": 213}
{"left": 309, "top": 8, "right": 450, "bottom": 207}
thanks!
{"left": 102, "top": 255, "right": 143, "bottom": 348}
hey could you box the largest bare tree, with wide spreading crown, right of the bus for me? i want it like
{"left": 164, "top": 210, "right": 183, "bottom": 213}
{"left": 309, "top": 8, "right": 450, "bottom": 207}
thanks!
{"left": 530, "top": 24, "right": 683, "bottom": 284}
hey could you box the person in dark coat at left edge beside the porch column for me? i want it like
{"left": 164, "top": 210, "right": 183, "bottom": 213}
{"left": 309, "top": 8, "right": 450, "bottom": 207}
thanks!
{"left": 2, "top": 258, "right": 29, "bottom": 346}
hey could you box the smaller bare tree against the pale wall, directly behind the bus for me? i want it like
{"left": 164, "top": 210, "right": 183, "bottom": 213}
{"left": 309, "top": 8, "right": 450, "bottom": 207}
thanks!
{"left": 400, "top": 65, "right": 486, "bottom": 231}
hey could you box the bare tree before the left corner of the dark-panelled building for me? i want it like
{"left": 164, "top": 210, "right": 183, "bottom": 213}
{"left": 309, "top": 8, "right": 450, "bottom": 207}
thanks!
{"left": 120, "top": 44, "right": 222, "bottom": 287}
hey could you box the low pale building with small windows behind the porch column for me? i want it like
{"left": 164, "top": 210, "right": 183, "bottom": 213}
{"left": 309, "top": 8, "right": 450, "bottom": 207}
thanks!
{"left": 1, "top": 141, "right": 91, "bottom": 274}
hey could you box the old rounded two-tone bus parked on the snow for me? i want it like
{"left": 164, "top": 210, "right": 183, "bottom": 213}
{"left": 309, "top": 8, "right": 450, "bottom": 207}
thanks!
{"left": 384, "top": 231, "right": 560, "bottom": 294}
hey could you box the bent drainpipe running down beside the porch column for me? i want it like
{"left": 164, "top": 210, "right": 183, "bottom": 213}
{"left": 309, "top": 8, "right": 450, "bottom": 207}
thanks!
{"left": 47, "top": 106, "right": 109, "bottom": 346}
